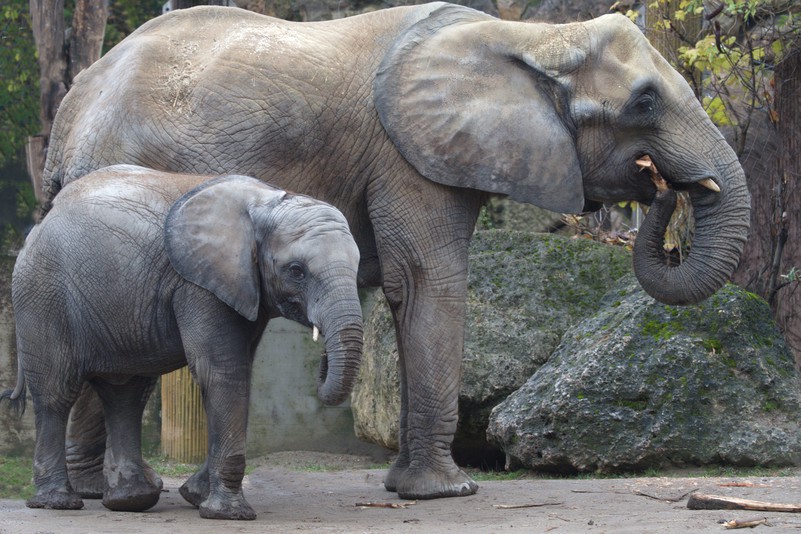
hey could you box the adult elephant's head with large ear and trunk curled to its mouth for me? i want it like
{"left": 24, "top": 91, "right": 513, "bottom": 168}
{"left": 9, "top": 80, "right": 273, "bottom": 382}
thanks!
{"left": 374, "top": 6, "right": 750, "bottom": 304}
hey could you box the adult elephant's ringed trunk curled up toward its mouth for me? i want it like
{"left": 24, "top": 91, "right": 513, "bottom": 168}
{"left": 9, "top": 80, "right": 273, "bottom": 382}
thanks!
{"left": 634, "top": 161, "right": 751, "bottom": 305}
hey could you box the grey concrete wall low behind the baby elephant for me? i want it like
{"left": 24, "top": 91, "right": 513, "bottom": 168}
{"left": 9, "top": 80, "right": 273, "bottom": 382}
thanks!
{"left": 0, "top": 256, "right": 385, "bottom": 457}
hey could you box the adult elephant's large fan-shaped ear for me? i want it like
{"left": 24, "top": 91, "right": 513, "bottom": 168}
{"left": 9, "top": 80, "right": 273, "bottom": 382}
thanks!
{"left": 374, "top": 6, "right": 585, "bottom": 213}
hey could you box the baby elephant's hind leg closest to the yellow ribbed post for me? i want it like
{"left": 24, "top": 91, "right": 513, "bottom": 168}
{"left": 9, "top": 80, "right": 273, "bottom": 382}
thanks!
{"left": 92, "top": 376, "right": 162, "bottom": 512}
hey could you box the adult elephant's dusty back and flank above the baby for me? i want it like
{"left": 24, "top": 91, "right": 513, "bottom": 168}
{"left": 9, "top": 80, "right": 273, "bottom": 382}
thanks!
{"left": 43, "top": 4, "right": 450, "bottom": 214}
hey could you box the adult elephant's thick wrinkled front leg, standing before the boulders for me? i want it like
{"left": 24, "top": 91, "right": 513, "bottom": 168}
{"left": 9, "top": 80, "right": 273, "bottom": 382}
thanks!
{"left": 374, "top": 184, "right": 479, "bottom": 499}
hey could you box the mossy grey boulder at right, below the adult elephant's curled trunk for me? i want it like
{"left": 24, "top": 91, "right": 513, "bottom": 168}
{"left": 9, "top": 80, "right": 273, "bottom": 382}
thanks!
{"left": 488, "top": 277, "right": 801, "bottom": 472}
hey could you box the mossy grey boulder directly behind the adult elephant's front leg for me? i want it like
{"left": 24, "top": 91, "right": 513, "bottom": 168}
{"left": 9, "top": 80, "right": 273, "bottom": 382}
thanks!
{"left": 352, "top": 230, "right": 631, "bottom": 464}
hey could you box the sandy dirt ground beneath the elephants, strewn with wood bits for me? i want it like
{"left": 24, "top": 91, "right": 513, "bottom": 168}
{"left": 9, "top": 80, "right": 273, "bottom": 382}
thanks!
{"left": 0, "top": 453, "right": 801, "bottom": 534}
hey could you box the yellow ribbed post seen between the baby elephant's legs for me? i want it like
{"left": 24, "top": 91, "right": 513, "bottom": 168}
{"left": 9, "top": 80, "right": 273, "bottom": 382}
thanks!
{"left": 161, "top": 367, "right": 208, "bottom": 464}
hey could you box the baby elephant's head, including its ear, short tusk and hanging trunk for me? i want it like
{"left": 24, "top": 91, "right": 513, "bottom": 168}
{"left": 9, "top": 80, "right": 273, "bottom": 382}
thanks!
{"left": 165, "top": 176, "right": 363, "bottom": 405}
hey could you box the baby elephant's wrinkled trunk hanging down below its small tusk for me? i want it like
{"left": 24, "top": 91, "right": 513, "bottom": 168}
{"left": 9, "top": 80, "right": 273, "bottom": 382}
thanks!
{"left": 317, "top": 288, "right": 364, "bottom": 406}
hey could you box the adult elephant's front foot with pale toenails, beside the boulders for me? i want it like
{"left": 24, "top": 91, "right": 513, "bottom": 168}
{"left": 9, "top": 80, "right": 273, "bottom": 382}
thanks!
{"left": 394, "top": 464, "right": 478, "bottom": 500}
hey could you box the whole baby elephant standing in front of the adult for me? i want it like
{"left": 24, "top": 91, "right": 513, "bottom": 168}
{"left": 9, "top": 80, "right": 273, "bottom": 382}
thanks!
{"left": 0, "top": 165, "right": 363, "bottom": 519}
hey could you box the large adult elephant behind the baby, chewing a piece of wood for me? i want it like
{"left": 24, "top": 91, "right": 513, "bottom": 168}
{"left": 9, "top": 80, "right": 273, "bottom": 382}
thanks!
{"left": 39, "top": 3, "right": 750, "bottom": 504}
